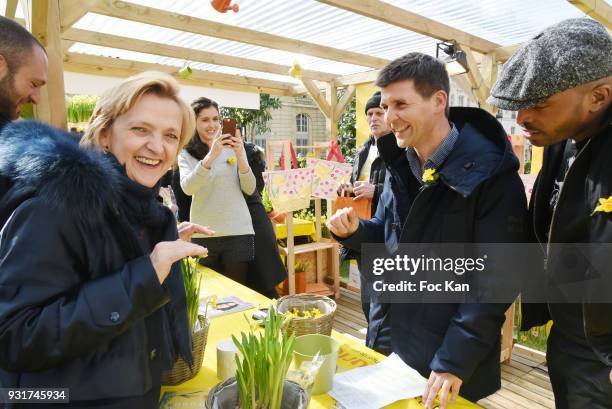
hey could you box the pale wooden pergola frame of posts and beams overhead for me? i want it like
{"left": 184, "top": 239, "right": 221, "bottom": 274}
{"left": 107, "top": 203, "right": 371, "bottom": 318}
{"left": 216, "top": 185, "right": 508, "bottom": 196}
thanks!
{"left": 4, "top": 0, "right": 612, "bottom": 135}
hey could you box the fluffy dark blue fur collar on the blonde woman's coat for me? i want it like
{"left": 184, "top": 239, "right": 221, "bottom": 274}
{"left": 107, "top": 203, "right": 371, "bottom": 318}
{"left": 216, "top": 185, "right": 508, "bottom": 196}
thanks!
{"left": 0, "top": 121, "right": 121, "bottom": 221}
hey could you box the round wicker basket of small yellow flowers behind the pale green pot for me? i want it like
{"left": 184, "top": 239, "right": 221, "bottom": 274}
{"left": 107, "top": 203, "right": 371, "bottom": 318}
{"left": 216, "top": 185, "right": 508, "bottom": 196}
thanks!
{"left": 276, "top": 294, "right": 336, "bottom": 337}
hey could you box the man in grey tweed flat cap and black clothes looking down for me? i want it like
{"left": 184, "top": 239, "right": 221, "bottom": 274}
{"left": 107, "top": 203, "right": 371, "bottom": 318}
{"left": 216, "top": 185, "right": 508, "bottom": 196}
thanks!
{"left": 488, "top": 18, "right": 612, "bottom": 409}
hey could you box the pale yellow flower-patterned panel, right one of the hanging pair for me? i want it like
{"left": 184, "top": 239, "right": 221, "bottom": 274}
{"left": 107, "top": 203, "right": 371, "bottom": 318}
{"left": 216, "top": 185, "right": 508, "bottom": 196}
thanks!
{"left": 306, "top": 158, "right": 353, "bottom": 200}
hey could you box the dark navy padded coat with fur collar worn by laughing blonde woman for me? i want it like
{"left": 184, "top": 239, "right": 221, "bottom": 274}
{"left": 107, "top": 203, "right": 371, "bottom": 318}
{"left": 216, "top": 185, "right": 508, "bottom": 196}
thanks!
{"left": 0, "top": 122, "right": 191, "bottom": 407}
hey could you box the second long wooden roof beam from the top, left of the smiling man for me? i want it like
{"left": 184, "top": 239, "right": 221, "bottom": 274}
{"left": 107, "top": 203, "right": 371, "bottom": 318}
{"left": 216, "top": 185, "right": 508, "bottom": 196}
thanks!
{"left": 63, "top": 28, "right": 336, "bottom": 81}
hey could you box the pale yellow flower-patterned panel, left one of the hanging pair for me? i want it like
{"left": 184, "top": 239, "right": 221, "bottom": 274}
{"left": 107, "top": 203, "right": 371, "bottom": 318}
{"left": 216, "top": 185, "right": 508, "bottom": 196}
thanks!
{"left": 264, "top": 168, "right": 313, "bottom": 213}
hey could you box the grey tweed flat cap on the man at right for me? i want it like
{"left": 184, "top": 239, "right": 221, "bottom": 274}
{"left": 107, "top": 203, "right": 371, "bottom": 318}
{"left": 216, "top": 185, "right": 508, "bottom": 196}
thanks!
{"left": 487, "top": 18, "right": 612, "bottom": 111}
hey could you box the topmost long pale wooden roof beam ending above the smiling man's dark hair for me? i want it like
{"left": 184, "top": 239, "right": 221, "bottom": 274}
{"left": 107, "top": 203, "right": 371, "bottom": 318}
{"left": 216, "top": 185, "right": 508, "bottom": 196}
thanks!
{"left": 91, "top": 0, "right": 386, "bottom": 68}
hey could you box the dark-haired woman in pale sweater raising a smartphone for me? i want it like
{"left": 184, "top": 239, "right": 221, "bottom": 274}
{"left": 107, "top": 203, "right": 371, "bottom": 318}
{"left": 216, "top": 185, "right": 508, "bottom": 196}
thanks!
{"left": 178, "top": 98, "right": 256, "bottom": 284}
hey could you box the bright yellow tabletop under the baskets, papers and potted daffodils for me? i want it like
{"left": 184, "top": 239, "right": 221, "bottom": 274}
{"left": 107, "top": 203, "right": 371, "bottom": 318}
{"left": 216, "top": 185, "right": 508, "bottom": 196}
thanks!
{"left": 162, "top": 268, "right": 480, "bottom": 409}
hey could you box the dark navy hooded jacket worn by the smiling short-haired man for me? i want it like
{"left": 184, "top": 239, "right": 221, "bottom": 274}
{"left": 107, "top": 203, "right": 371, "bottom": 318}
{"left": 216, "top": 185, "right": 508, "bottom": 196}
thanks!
{"left": 343, "top": 108, "right": 527, "bottom": 401}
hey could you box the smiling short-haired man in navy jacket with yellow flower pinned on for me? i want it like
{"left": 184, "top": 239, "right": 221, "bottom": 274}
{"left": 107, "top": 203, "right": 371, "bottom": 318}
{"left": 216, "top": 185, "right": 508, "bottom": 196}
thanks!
{"left": 328, "top": 53, "right": 527, "bottom": 408}
